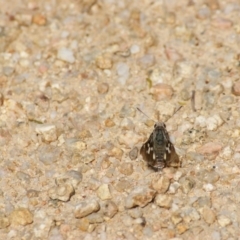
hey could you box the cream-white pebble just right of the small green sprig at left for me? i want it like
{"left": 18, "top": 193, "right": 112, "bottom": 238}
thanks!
{"left": 35, "top": 124, "right": 58, "bottom": 142}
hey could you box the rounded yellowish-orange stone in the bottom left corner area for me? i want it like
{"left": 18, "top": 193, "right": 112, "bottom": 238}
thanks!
{"left": 9, "top": 208, "right": 33, "bottom": 226}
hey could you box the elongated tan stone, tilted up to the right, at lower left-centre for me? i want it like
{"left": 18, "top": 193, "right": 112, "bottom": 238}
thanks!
{"left": 74, "top": 200, "right": 100, "bottom": 218}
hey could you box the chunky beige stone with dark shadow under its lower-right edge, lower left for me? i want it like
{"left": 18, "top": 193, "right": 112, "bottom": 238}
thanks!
{"left": 48, "top": 183, "right": 75, "bottom": 202}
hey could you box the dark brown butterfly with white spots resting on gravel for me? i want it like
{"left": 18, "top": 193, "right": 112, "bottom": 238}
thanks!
{"left": 138, "top": 109, "right": 181, "bottom": 171}
